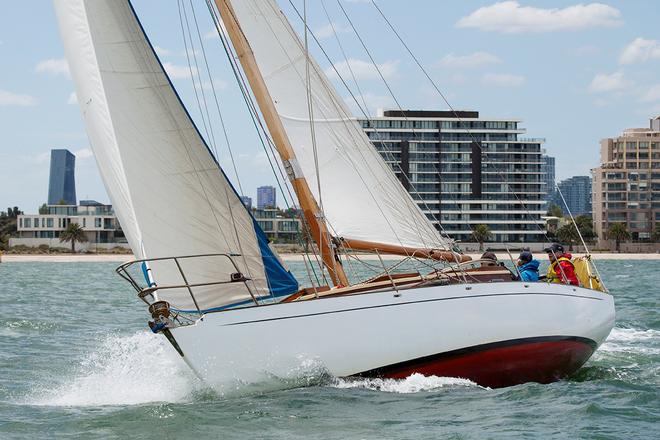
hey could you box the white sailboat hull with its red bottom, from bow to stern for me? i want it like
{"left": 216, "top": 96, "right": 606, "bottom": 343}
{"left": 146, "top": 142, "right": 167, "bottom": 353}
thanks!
{"left": 172, "top": 282, "right": 615, "bottom": 390}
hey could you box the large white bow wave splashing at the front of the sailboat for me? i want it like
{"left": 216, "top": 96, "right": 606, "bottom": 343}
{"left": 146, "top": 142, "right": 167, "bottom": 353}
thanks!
{"left": 25, "top": 332, "right": 202, "bottom": 406}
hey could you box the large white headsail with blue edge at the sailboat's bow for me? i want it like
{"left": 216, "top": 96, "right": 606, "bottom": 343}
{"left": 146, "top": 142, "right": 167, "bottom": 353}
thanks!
{"left": 55, "top": 0, "right": 297, "bottom": 309}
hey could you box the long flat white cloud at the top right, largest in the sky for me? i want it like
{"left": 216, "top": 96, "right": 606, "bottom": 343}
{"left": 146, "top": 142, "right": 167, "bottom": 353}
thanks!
{"left": 456, "top": 1, "right": 622, "bottom": 34}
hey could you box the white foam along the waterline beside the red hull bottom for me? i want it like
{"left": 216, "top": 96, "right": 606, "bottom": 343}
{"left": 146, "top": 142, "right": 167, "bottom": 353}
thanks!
{"left": 330, "top": 373, "right": 479, "bottom": 394}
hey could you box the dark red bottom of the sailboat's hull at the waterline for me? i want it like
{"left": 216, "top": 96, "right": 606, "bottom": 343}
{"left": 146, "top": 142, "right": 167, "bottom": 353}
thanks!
{"left": 359, "top": 336, "right": 596, "bottom": 388}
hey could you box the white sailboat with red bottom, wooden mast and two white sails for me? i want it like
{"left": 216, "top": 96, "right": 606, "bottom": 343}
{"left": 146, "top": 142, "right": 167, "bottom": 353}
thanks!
{"left": 55, "top": 0, "right": 615, "bottom": 390}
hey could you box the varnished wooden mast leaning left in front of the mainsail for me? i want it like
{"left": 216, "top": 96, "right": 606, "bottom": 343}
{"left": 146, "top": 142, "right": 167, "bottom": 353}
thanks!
{"left": 215, "top": 0, "right": 348, "bottom": 286}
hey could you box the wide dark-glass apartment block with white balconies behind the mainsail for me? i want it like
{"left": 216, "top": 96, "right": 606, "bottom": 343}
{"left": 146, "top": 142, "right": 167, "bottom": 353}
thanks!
{"left": 361, "top": 110, "right": 545, "bottom": 243}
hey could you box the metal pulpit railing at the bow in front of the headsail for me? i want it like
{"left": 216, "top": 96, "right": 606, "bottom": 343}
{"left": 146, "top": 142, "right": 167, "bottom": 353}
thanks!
{"left": 115, "top": 254, "right": 259, "bottom": 315}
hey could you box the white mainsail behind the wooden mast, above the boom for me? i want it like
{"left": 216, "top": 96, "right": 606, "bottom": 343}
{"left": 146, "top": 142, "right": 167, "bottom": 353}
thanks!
{"left": 226, "top": 0, "right": 449, "bottom": 249}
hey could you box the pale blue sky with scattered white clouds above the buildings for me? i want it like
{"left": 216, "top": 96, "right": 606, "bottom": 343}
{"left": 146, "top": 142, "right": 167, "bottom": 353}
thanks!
{"left": 0, "top": 0, "right": 660, "bottom": 213}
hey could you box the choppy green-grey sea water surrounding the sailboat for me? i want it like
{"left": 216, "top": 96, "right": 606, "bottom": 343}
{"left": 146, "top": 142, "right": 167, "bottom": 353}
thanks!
{"left": 0, "top": 260, "right": 660, "bottom": 439}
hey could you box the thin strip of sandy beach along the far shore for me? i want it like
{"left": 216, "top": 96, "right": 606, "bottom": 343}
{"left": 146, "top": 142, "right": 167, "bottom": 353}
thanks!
{"left": 0, "top": 252, "right": 660, "bottom": 263}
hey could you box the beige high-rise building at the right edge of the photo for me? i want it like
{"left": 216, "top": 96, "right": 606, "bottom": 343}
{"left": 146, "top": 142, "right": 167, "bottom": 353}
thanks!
{"left": 592, "top": 116, "right": 660, "bottom": 240}
